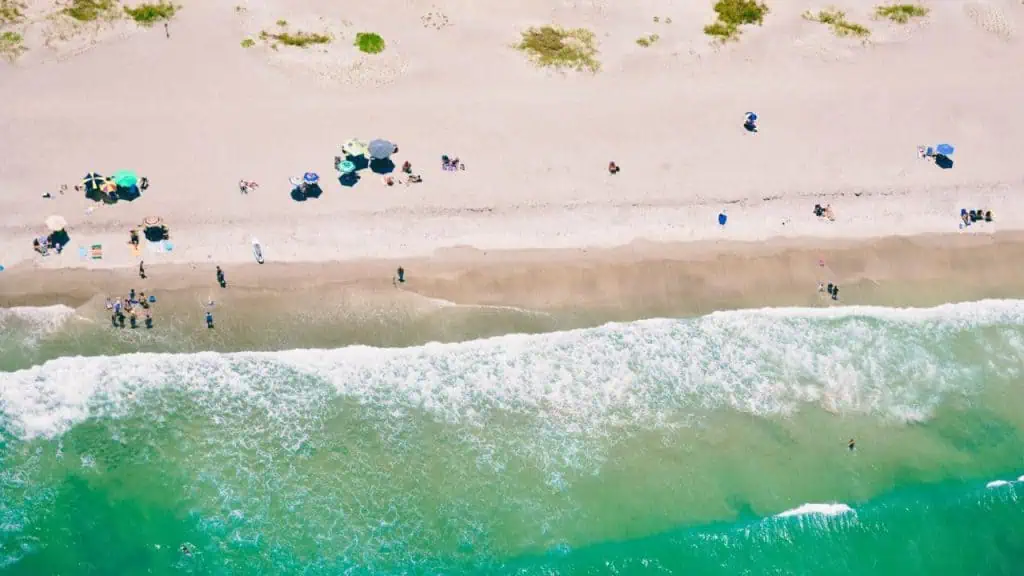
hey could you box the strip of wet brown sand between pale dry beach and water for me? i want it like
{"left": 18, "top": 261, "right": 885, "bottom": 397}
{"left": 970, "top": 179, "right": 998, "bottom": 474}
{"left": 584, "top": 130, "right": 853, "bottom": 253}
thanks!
{"left": 0, "top": 233, "right": 1024, "bottom": 327}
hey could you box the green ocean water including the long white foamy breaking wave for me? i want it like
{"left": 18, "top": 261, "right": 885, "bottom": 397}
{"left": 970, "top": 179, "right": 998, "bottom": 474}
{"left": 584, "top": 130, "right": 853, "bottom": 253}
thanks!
{"left": 0, "top": 300, "right": 1024, "bottom": 575}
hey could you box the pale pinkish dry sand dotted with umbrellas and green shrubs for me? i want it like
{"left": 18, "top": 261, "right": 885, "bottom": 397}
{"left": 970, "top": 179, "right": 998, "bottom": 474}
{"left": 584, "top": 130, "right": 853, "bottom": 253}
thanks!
{"left": 0, "top": 0, "right": 1024, "bottom": 270}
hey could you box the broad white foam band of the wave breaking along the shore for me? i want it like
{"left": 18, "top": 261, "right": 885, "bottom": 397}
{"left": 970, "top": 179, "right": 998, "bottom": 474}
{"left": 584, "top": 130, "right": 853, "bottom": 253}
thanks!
{"left": 0, "top": 300, "right": 1024, "bottom": 438}
